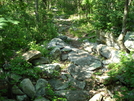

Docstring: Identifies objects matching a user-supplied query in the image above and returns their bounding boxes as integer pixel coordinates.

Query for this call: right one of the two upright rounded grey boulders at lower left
[35,79,48,96]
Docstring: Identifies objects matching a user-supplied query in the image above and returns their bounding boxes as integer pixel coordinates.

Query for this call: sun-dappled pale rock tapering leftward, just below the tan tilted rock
[36,63,61,76]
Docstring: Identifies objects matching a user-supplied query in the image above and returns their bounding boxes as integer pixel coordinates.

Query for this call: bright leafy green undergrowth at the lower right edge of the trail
[107,53,134,101]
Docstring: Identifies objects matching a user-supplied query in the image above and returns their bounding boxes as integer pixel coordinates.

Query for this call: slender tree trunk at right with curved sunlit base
[117,0,129,52]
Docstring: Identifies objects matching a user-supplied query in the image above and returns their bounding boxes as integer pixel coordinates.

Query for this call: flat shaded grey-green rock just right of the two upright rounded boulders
[49,79,69,90]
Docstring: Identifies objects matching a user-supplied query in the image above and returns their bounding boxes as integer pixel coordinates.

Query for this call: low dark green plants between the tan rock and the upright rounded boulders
[6,57,41,79]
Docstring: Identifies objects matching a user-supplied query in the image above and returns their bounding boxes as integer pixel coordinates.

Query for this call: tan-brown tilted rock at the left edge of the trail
[22,50,42,61]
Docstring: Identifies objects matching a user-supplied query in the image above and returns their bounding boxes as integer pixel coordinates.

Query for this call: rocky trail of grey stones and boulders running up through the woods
[2,13,133,101]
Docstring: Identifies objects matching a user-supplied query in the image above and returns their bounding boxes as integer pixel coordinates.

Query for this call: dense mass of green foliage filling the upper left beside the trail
[0,0,57,66]
